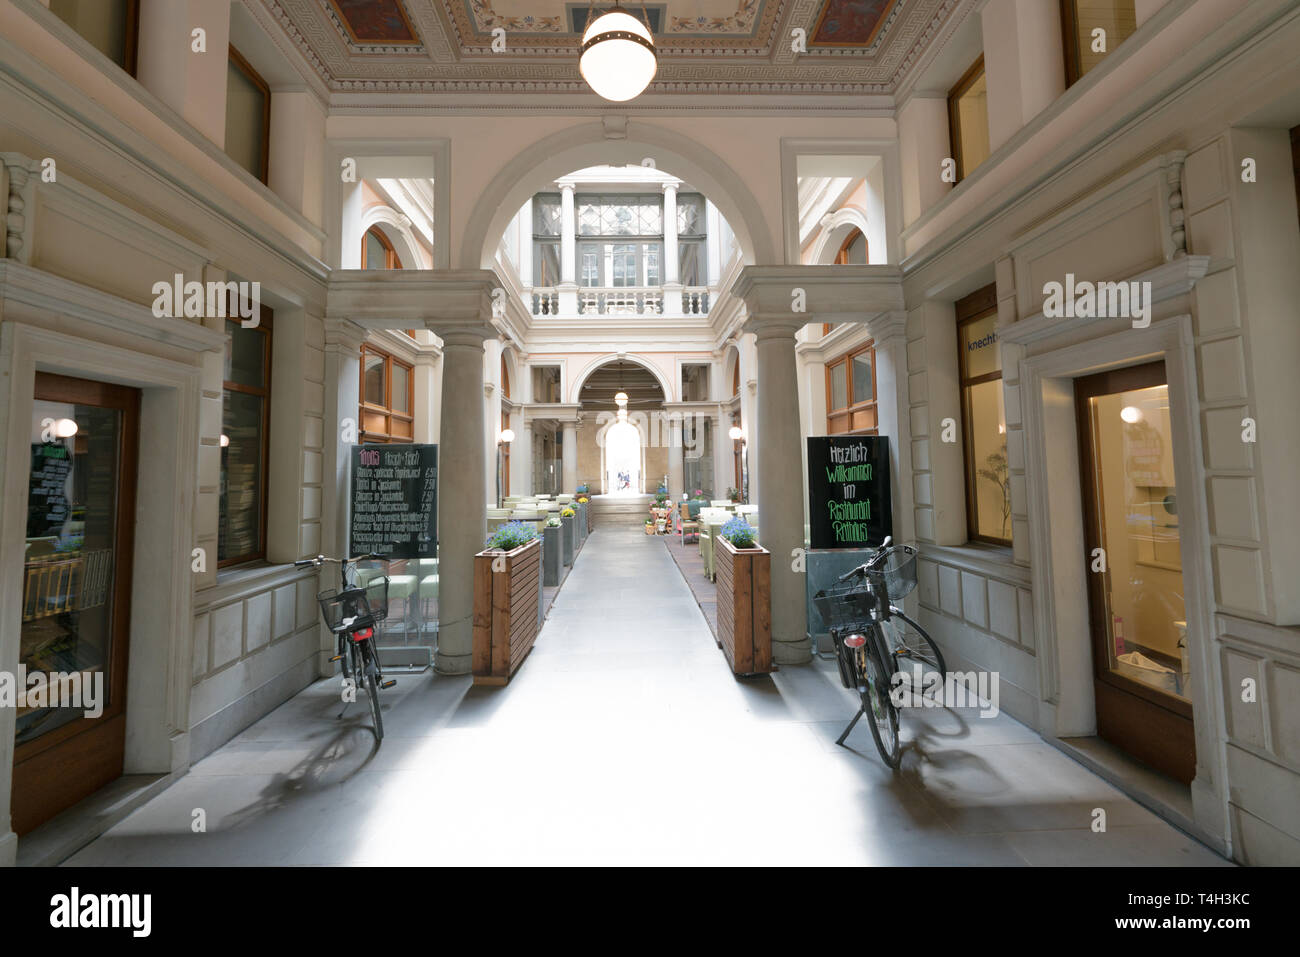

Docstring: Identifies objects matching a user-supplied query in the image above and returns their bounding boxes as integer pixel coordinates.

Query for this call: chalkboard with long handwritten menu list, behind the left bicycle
[348,445,438,562]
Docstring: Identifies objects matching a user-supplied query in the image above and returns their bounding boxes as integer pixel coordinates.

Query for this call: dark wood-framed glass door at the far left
[12,372,139,835]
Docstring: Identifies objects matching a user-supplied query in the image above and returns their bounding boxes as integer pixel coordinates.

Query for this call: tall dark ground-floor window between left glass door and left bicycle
[217,303,273,567]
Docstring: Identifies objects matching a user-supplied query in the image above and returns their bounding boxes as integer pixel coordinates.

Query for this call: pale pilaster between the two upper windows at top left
[135,0,230,148]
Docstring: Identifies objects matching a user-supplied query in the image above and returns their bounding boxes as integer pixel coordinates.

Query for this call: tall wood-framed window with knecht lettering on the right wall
[957,285,1011,545]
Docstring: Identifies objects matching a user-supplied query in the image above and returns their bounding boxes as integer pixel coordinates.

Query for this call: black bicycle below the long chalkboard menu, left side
[294,553,397,741]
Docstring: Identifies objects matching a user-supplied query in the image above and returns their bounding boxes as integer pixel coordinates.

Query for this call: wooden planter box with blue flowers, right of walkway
[714,536,772,675]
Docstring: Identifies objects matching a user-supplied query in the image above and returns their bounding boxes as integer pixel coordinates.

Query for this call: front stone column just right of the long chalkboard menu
[434,324,494,675]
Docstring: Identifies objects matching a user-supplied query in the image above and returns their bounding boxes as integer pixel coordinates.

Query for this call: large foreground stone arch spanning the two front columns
[458,122,777,269]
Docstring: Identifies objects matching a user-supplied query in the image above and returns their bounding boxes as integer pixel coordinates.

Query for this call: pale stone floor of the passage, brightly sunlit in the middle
[69,527,1226,865]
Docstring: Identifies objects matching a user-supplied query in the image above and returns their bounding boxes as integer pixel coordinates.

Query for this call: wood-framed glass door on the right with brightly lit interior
[1075,361,1196,783]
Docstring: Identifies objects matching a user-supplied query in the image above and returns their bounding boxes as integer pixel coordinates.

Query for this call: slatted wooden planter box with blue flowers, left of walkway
[471,538,542,685]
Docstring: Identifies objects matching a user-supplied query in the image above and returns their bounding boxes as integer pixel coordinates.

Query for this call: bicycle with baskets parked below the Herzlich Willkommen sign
[813,537,948,768]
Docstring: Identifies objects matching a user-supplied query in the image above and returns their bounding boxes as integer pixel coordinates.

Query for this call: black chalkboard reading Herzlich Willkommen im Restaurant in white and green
[809,436,893,549]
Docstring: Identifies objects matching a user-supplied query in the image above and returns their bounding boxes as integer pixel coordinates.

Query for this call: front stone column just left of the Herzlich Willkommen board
[745,313,811,664]
